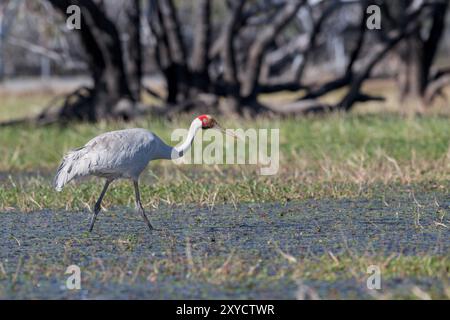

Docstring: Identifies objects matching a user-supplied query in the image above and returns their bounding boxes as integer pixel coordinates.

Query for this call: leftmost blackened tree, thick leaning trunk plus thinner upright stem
[40,0,142,122]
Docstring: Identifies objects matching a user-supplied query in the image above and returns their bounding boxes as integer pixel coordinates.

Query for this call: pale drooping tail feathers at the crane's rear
[53,147,87,191]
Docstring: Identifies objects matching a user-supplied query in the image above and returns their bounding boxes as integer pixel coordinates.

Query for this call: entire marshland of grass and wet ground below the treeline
[0,91,450,299]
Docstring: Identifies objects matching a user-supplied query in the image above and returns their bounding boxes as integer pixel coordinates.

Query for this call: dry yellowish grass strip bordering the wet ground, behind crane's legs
[0,162,450,212]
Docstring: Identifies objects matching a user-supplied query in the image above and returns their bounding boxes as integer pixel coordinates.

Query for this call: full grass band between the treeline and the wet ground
[0,114,450,211]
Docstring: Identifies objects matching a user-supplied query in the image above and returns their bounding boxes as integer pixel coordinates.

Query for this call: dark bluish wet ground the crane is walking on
[0,194,450,299]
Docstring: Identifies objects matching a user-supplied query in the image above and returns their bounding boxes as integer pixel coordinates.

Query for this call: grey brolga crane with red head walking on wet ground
[54,115,227,232]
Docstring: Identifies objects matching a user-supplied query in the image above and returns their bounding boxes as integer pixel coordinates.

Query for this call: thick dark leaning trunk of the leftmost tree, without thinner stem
[49,0,136,121]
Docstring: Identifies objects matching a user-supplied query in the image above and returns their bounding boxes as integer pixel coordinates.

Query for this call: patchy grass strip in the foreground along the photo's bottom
[0,251,450,299]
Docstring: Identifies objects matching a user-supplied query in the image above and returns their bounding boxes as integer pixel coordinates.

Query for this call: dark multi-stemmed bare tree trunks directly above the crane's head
[149,0,305,113]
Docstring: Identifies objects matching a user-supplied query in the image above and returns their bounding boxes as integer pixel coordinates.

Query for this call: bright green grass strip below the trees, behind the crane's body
[0,115,450,171]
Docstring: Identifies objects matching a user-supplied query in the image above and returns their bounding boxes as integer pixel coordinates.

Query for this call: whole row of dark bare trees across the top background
[0,0,450,122]
